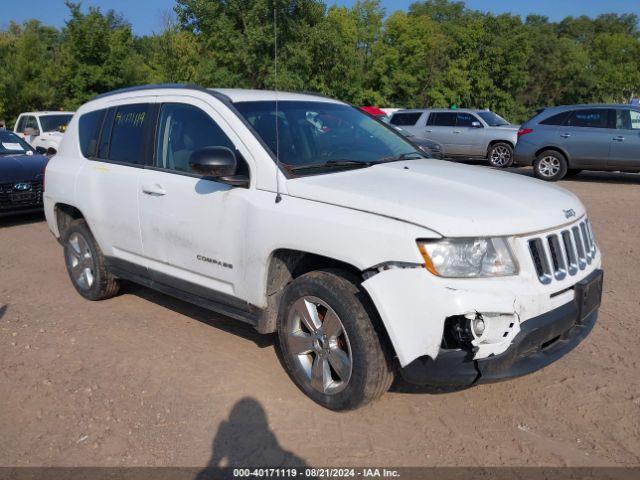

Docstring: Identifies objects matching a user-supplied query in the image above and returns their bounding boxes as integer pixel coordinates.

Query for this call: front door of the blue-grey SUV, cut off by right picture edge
[609,108,640,170]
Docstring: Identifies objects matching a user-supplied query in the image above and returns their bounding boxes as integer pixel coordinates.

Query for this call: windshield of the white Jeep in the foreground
[235,101,423,172]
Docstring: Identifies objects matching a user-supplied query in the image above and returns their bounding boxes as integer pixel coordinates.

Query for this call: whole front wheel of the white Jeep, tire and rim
[278,270,394,410]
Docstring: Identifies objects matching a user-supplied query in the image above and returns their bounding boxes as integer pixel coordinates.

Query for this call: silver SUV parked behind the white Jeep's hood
[390,109,518,168]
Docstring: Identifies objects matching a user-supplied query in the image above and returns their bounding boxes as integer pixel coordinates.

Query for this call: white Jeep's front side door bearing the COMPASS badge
[138,95,250,308]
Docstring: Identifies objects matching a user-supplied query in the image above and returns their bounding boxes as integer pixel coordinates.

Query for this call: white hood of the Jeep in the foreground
[287,160,584,237]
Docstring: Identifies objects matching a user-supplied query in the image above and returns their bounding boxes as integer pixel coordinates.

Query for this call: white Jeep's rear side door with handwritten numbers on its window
[76,98,153,276]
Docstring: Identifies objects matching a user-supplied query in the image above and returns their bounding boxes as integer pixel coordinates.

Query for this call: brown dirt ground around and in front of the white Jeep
[0,170,640,466]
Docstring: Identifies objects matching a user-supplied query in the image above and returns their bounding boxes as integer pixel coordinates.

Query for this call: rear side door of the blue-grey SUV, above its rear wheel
[557,108,615,167]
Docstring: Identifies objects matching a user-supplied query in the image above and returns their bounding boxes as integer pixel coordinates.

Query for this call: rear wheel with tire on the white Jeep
[62,220,120,300]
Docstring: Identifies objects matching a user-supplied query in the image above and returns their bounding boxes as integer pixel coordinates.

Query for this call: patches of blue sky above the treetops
[5,0,640,34]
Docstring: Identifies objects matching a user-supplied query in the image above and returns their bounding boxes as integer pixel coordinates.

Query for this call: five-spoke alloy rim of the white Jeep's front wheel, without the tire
[286,296,353,395]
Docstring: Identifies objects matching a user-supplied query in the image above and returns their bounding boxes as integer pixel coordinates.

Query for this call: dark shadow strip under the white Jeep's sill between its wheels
[121,282,276,348]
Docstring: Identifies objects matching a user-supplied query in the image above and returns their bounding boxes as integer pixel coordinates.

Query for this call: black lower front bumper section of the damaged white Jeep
[401,270,602,387]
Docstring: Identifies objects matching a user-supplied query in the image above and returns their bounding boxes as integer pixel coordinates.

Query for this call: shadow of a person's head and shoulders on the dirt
[196,397,307,480]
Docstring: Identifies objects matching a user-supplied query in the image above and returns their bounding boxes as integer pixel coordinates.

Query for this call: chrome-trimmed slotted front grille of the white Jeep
[528,219,596,284]
